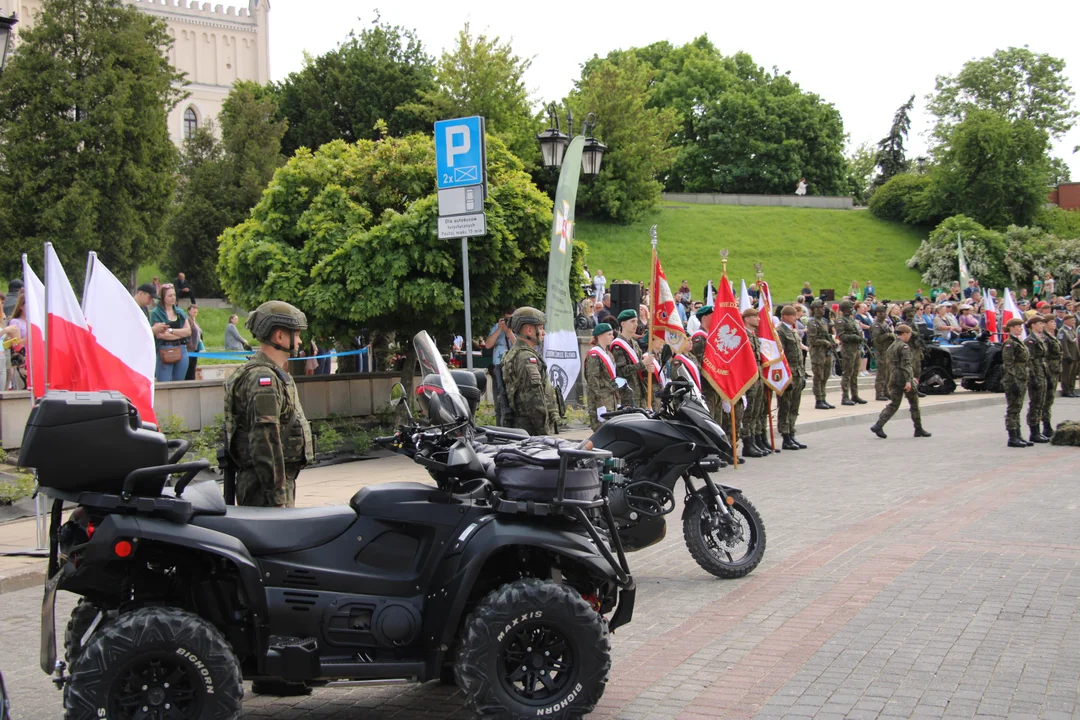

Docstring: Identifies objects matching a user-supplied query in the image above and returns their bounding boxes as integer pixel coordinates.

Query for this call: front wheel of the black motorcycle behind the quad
[683,492,765,580]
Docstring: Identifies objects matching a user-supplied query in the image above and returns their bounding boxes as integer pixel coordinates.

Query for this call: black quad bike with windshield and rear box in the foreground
[27,332,635,720]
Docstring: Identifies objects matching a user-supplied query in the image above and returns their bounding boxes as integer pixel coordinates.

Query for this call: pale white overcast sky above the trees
[263,0,1080,180]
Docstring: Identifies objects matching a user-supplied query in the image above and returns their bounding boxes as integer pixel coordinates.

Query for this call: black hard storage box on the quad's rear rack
[18,391,168,495]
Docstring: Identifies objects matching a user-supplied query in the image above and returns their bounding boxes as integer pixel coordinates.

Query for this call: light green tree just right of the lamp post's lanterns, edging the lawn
[570,55,678,223]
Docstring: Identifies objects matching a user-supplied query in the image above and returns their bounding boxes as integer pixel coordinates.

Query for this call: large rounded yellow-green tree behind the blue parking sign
[218,135,583,382]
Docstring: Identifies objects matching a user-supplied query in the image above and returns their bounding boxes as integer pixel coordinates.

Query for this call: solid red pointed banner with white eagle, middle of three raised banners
[702,275,758,405]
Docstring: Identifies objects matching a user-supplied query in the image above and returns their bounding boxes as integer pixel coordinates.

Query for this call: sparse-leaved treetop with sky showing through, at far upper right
[927,45,1078,138]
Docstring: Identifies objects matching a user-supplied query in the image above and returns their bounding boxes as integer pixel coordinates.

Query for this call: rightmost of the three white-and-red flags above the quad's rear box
[82,253,158,423]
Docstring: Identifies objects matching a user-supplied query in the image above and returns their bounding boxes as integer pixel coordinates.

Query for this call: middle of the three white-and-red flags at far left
[45,243,103,391]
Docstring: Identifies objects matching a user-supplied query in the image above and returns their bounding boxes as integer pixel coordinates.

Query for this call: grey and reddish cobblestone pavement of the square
[0,399,1080,720]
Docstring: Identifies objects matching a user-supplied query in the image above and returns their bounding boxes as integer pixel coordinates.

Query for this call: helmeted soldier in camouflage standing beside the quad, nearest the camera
[225,300,314,507]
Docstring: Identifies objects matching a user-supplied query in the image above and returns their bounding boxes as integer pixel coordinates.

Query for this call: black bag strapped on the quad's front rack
[495,437,600,502]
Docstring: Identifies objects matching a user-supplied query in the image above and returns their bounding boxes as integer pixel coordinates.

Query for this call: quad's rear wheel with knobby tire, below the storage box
[64,607,244,720]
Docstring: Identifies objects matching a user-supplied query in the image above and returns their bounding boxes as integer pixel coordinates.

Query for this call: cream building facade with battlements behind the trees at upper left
[15,0,270,145]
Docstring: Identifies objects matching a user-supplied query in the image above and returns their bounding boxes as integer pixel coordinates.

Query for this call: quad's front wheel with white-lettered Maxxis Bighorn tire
[454,580,611,720]
